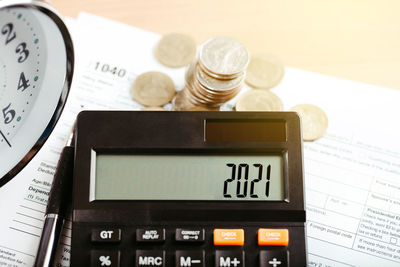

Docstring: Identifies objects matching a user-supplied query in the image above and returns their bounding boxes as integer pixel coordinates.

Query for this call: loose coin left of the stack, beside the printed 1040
[131,72,175,107]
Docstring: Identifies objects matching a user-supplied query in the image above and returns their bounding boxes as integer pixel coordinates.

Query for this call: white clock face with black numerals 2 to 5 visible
[0,6,69,182]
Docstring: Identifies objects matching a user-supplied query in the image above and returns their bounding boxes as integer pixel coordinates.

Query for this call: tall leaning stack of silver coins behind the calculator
[174,37,249,110]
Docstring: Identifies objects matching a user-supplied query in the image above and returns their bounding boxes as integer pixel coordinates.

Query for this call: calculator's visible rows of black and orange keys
[86,227,289,267]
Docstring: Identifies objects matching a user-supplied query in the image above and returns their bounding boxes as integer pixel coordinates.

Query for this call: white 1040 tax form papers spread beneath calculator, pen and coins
[0,13,400,267]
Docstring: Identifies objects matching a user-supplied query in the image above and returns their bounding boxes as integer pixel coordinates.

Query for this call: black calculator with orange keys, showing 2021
[71,111,306,267]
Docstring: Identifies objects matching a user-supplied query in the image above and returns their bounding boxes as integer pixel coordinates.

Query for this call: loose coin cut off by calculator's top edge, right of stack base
[235,90,283,111]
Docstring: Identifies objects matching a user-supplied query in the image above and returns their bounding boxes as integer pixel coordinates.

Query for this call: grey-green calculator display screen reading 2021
[90,154,285,201]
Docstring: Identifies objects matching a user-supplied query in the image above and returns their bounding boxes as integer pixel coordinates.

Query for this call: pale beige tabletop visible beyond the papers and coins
[52,0,400,89]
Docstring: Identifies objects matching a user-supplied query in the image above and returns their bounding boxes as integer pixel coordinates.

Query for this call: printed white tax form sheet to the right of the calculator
[268,69,400,267]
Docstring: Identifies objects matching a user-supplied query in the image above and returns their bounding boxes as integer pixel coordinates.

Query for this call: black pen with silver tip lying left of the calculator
[34,127,75,267]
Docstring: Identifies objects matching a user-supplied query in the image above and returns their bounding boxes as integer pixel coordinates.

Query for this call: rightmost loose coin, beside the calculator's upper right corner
[290,104,328,141]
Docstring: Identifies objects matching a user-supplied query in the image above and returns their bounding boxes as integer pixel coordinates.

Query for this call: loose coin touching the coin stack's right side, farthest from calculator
[246,55,284,88]
